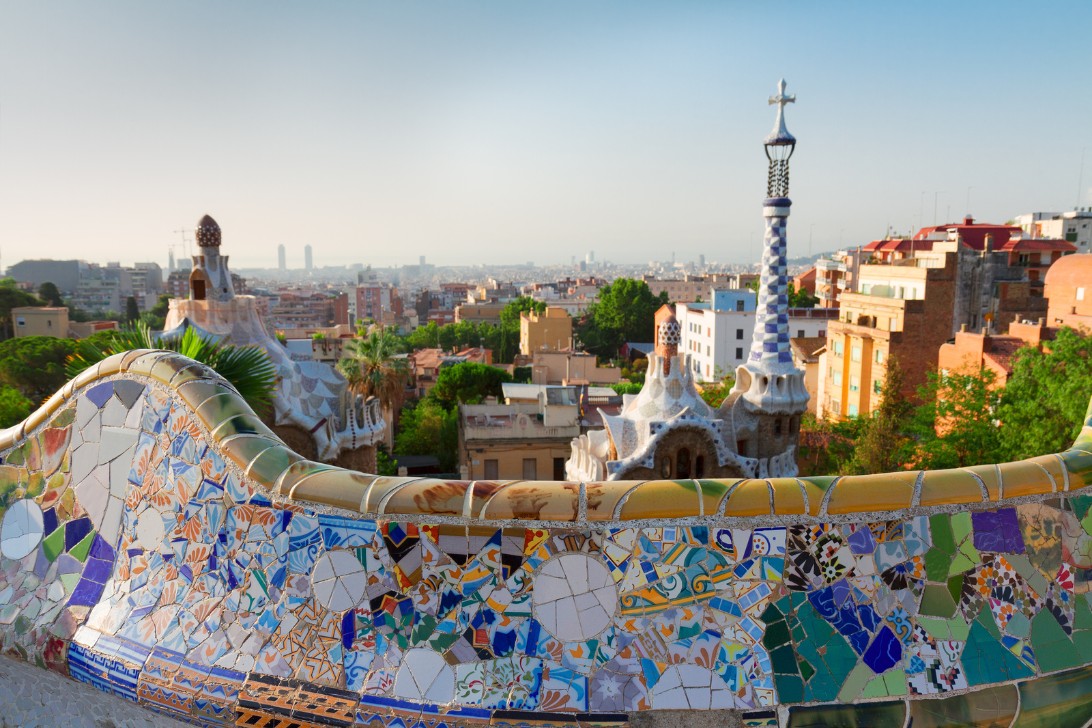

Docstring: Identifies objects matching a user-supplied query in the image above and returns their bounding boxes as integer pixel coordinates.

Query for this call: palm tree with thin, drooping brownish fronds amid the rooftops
[337,329,410,411]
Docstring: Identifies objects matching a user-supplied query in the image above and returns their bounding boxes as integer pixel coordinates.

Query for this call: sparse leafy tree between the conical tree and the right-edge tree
[909,369,1000,469]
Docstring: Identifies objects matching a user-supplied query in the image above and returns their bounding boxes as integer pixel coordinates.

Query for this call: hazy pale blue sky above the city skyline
[0,0,1092,266]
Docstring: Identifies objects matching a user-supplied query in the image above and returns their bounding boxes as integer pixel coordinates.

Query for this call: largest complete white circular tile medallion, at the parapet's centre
[532,553,618,642]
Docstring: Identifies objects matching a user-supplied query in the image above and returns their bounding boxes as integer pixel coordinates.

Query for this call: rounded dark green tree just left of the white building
[577,278,667,359]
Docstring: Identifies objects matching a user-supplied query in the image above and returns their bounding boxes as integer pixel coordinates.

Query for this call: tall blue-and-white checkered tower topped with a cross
[736,79,808,414]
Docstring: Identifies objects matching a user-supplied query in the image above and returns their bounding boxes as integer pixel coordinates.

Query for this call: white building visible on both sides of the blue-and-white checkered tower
[675,289,838,382]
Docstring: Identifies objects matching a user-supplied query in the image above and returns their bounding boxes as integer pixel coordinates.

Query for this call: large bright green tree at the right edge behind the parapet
[997,327,1092,460]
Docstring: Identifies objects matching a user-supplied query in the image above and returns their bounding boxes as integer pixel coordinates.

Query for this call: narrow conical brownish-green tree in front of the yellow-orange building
[841,357,913,475]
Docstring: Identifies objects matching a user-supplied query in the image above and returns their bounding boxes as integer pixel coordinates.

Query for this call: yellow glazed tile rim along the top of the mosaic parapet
[6,349,1092,522]
